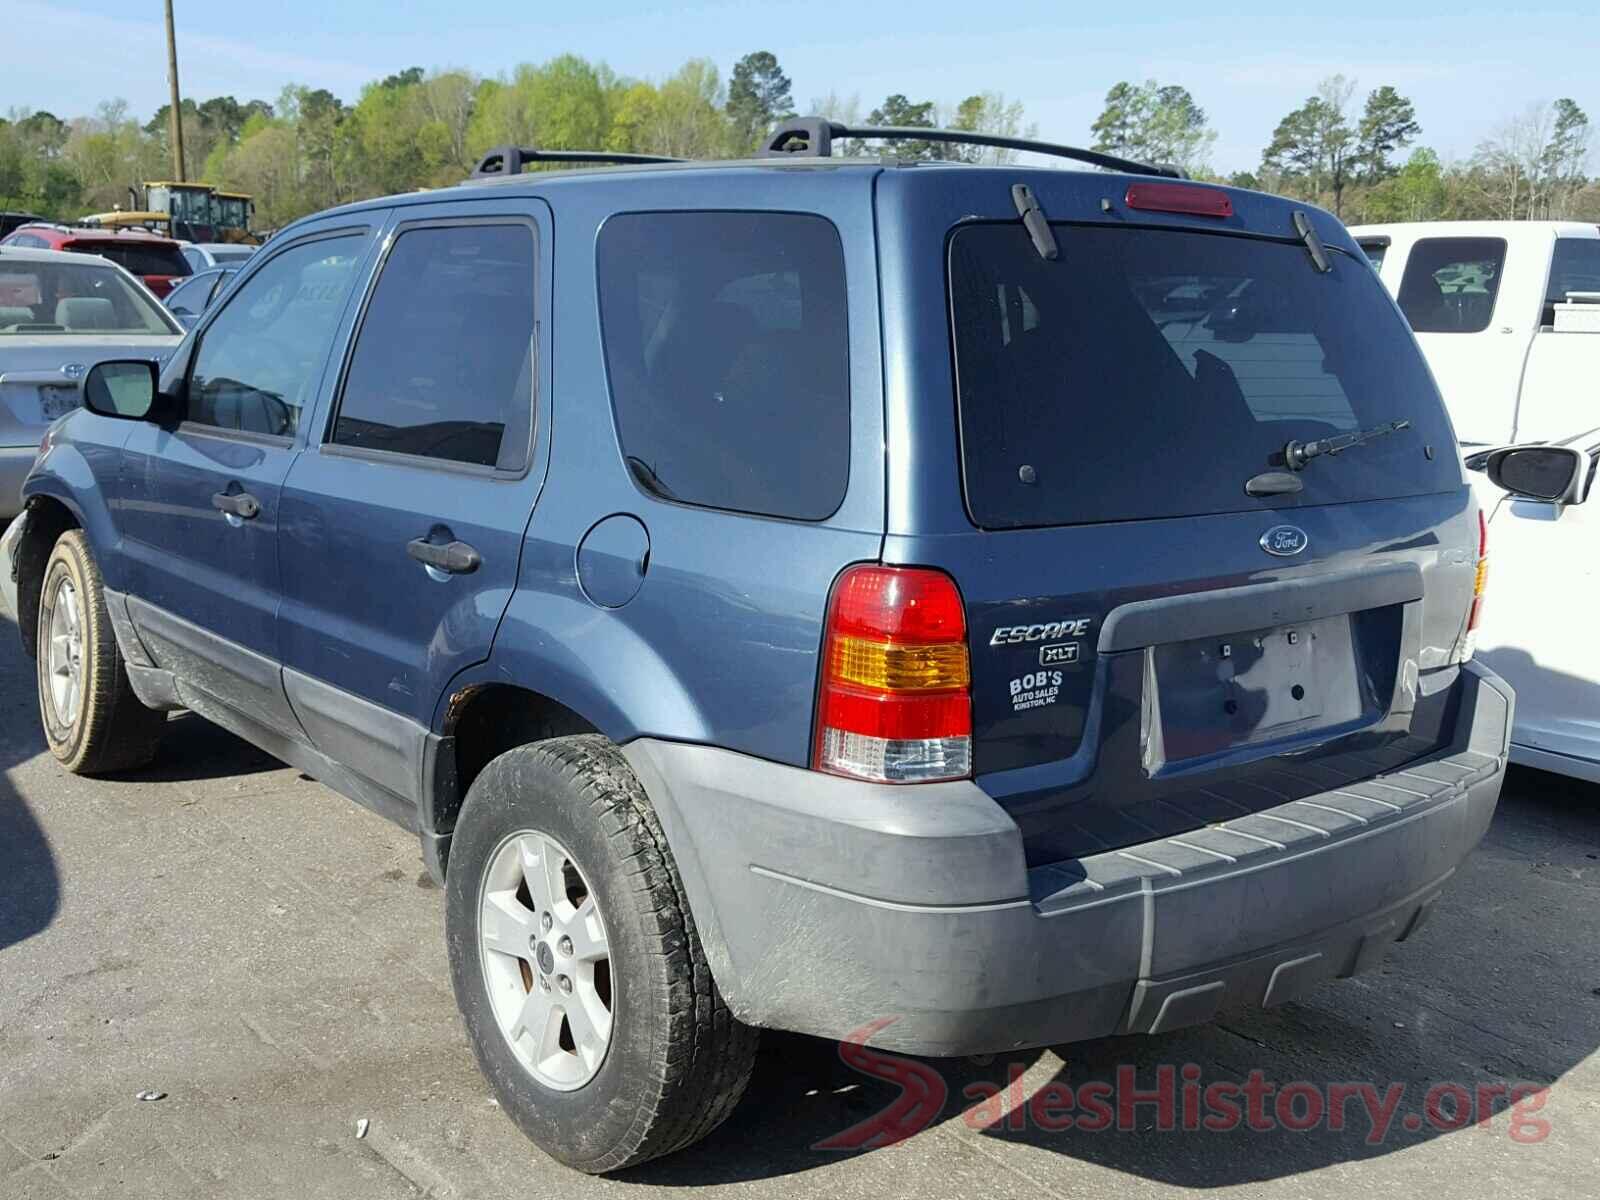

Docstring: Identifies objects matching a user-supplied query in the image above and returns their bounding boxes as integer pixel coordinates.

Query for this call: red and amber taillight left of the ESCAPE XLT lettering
[813,565,973,782]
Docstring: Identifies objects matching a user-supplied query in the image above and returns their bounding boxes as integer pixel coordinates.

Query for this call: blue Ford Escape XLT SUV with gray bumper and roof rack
[0,120,1512,1171]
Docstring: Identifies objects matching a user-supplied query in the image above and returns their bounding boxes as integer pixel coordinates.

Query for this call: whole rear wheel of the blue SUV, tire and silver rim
[445,734,757,1174]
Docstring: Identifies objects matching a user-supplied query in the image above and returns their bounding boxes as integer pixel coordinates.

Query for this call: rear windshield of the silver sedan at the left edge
[0,259,182,338]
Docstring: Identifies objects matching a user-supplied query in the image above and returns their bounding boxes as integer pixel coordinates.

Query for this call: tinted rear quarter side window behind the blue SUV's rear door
[598,213,850,520]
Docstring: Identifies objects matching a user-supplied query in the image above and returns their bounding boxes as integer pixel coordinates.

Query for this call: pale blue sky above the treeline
[0,0,1600,171]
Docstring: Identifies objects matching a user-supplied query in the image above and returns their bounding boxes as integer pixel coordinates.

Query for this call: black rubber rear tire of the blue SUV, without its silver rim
[445,734,757,1174]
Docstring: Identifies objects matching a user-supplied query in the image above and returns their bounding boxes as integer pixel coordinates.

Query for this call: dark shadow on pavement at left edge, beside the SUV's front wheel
[0,522,61,950]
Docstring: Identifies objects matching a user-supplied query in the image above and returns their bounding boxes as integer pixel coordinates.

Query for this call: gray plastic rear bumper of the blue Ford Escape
[626,664,1512,1054]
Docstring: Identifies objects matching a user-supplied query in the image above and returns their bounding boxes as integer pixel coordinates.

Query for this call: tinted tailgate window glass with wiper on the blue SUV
[949,224,1461,528]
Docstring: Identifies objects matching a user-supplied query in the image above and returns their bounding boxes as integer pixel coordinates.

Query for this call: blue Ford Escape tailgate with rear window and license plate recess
[880,171,1477,864]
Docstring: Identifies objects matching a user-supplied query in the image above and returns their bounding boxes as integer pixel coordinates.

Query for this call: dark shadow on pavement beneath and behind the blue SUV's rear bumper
[619,768,1600,1189]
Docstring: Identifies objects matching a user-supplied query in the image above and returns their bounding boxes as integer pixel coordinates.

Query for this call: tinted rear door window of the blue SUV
[333,224,538,472]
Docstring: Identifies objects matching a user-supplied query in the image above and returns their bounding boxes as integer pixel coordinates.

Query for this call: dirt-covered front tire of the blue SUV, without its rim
[34,530,166,774]
